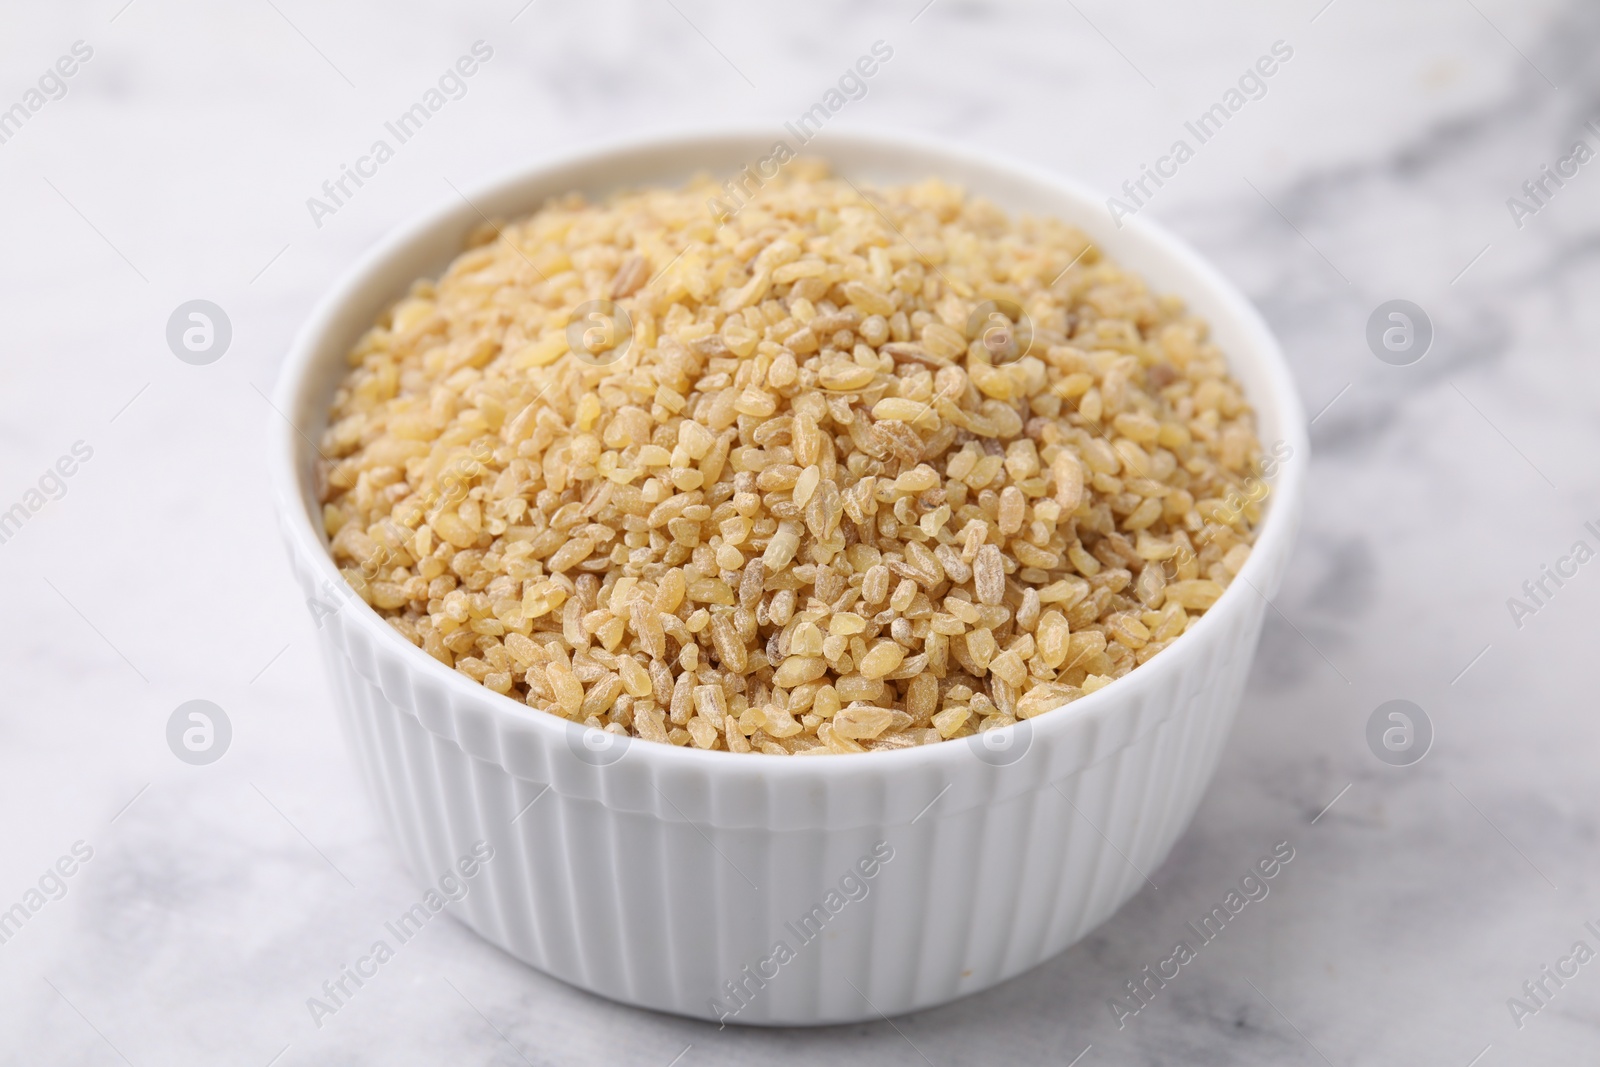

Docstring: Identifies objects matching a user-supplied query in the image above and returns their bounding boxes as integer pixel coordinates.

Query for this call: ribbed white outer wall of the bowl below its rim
[284,521,1286,1024]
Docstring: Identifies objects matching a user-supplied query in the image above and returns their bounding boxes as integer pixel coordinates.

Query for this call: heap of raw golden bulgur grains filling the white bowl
[323,160,1261,755]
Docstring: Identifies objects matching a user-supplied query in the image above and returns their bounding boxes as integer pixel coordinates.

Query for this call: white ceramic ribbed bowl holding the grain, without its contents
[272,130,1309,1024]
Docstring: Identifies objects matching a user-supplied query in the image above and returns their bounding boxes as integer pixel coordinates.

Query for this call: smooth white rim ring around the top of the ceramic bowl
[267,123,1310,779]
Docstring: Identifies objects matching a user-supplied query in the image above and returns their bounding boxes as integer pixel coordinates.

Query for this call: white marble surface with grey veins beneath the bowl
[0,0,1600,1067]
